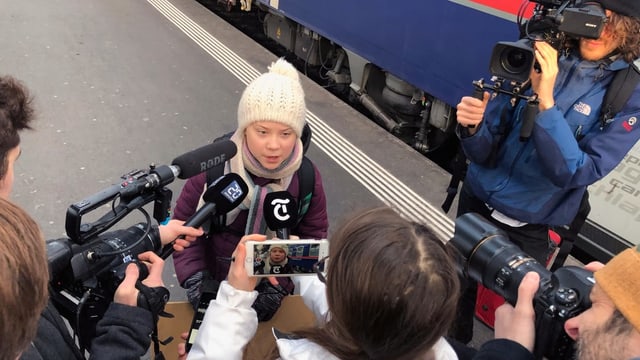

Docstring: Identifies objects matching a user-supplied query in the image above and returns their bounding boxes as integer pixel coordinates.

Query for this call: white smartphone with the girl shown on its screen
[245,239,329,277]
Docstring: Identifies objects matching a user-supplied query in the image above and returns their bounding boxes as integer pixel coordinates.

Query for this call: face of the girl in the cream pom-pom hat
[244,121,298,170]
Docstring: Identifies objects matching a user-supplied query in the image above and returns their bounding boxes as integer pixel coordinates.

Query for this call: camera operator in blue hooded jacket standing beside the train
[452,0,640,343]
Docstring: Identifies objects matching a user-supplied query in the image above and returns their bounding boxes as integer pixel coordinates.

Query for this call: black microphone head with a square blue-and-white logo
[202,173,249,214]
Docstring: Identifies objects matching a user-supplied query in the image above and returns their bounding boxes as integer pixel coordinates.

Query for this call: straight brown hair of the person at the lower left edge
[0,197,49,360]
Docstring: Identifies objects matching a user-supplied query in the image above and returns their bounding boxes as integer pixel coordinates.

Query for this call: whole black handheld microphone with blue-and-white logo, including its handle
[160,173,249,259]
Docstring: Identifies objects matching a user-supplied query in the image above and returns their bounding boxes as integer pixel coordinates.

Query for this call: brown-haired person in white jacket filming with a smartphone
[188,207,459,360]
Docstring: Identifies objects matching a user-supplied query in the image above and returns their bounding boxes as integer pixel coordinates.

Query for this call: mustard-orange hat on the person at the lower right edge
[595,246,640,331]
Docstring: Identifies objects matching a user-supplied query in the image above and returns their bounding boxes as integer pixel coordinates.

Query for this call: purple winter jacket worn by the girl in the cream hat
[173,165,329,285]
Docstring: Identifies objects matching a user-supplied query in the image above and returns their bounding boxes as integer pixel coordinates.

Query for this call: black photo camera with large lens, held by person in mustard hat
[448,213,594,360]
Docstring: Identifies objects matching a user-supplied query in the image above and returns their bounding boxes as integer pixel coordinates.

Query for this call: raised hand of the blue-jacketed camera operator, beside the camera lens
[531,41,558,111]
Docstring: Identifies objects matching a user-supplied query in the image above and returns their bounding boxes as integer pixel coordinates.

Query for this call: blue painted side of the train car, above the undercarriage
[259,0,520,105]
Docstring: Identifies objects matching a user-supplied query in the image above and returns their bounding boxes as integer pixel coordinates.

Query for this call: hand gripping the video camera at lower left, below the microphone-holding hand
[113,251,164,306]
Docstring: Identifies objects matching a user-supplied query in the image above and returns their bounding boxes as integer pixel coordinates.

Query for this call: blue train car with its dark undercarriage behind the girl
[248,0,519,153]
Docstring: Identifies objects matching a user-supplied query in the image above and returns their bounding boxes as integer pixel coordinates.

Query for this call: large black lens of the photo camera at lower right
[450,213,552,304]
